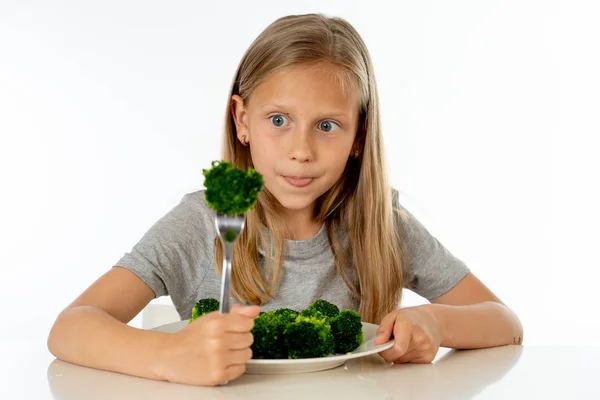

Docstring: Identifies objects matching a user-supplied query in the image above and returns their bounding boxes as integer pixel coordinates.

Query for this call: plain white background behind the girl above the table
[0,0,600,354]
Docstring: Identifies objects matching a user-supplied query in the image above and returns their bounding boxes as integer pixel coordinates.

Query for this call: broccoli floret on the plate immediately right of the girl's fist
[251,308,298,359]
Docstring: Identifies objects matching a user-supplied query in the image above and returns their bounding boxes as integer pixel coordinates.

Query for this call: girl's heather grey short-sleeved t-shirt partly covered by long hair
[115,190,469,319]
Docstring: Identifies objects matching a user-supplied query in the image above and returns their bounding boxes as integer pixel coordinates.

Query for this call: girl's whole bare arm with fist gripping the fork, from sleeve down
[48,268,260,386]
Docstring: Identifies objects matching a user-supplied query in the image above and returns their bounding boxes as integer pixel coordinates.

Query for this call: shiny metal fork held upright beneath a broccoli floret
[215,214,246,314]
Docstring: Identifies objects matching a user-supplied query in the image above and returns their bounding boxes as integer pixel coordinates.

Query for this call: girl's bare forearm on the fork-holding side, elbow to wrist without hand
[48,306,165,379]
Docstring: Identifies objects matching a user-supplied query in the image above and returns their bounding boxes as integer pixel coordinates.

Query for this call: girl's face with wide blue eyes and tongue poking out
[232,64,359,211]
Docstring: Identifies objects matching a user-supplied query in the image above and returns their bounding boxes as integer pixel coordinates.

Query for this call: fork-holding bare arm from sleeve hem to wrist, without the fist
[48,268,165,379]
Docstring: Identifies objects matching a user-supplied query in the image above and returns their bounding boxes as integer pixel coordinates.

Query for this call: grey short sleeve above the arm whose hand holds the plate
[392,190,469,300]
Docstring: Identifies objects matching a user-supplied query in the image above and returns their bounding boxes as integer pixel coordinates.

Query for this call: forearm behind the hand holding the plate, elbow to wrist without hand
[422,301,523,349]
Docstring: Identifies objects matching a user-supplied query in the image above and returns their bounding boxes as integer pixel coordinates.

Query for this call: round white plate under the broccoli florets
[152,320,394,374]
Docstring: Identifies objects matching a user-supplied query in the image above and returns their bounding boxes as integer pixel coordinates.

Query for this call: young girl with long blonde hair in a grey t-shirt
[48,15,523,385]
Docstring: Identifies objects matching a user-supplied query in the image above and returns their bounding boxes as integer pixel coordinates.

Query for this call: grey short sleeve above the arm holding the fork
[114,193,214,304]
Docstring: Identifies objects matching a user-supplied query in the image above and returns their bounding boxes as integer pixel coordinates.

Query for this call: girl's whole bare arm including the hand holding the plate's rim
[375,273,523,363]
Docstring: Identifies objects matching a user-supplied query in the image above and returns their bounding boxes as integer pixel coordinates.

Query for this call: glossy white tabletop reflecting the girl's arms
[0,335,600,400]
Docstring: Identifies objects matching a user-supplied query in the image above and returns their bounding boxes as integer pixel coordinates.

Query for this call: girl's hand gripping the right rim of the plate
[375,306,441,364]
